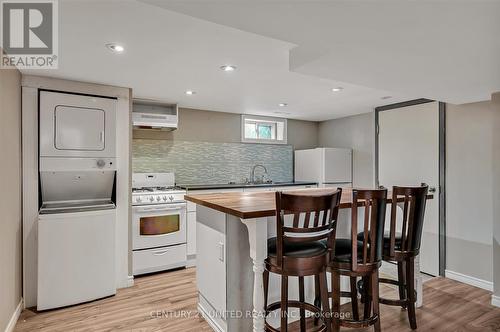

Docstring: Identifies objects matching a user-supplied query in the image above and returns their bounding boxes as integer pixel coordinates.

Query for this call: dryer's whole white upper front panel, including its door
[40,91,116,158]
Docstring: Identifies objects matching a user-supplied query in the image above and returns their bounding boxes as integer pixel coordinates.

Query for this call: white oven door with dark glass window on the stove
[132,203,186,250]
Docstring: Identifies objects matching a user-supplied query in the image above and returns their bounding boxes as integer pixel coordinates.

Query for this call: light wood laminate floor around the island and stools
[15,268,500,332]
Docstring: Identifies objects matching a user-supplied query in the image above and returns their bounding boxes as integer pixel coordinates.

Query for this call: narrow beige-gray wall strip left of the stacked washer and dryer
[0,66,22,331]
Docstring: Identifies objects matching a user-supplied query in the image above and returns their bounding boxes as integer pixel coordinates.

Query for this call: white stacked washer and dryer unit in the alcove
[37,91,116,310]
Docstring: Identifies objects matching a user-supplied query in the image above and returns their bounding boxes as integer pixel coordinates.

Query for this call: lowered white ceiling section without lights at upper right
[143,0,500,104]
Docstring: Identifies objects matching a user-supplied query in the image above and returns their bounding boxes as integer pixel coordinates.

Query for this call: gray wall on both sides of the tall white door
[318,102,500,286]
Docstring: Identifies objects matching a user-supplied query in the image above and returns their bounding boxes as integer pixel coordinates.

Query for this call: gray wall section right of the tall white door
[446,101,495,282]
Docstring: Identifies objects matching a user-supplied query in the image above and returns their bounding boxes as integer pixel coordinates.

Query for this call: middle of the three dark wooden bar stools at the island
[327,189,387,331]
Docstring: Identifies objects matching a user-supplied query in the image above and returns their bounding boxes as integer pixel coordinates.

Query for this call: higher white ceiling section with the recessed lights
[24,0,419,120]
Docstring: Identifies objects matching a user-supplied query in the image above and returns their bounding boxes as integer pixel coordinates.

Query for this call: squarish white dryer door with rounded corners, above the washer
[54,105,105,151]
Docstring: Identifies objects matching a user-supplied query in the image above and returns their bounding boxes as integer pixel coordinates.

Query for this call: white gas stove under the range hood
[132,173,187,275]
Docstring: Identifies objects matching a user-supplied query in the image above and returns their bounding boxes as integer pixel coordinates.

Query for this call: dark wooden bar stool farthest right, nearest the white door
[379,184,429,329]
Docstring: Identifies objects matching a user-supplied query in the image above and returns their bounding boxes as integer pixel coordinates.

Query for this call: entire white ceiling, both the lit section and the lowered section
[24,0,500,121]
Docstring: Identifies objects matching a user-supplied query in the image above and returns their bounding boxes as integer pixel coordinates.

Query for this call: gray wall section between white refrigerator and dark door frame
[318,112,375,187]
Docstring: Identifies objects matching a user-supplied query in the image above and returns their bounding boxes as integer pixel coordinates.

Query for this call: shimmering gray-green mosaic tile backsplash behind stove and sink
[132,139,293,184]
